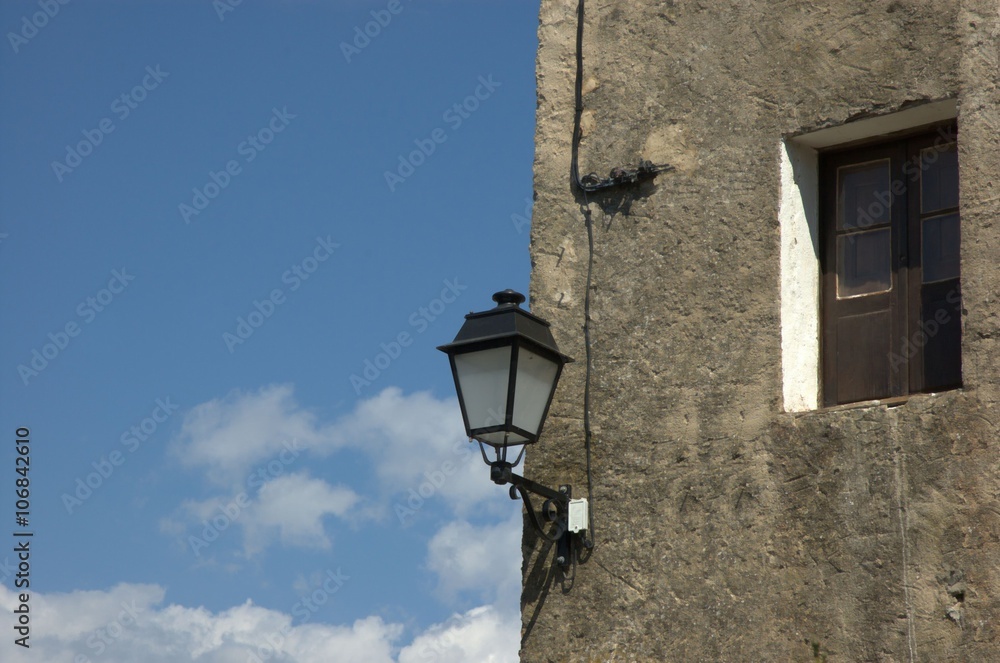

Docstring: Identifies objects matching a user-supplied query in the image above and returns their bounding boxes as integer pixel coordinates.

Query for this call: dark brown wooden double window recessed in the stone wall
[819,123,962,405]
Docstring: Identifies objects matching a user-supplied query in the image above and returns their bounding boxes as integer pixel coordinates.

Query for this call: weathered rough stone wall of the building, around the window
[521,0,1000,663]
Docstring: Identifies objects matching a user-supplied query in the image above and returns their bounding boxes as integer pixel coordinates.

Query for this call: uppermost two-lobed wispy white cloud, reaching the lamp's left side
[171,385,503,516]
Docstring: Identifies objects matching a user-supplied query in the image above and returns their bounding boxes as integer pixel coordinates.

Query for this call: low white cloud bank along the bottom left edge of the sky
[0,584,402,663]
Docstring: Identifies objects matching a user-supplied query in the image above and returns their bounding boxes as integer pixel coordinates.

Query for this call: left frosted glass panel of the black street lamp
[455,346,510,430]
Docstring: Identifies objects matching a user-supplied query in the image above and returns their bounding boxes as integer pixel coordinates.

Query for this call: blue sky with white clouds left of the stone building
[0,0,538,663]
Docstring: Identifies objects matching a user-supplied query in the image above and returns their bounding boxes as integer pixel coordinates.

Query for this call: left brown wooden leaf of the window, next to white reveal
[820,145,909,405]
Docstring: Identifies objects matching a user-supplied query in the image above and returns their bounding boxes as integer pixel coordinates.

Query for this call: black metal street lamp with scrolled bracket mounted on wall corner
[438,290,588,565]
